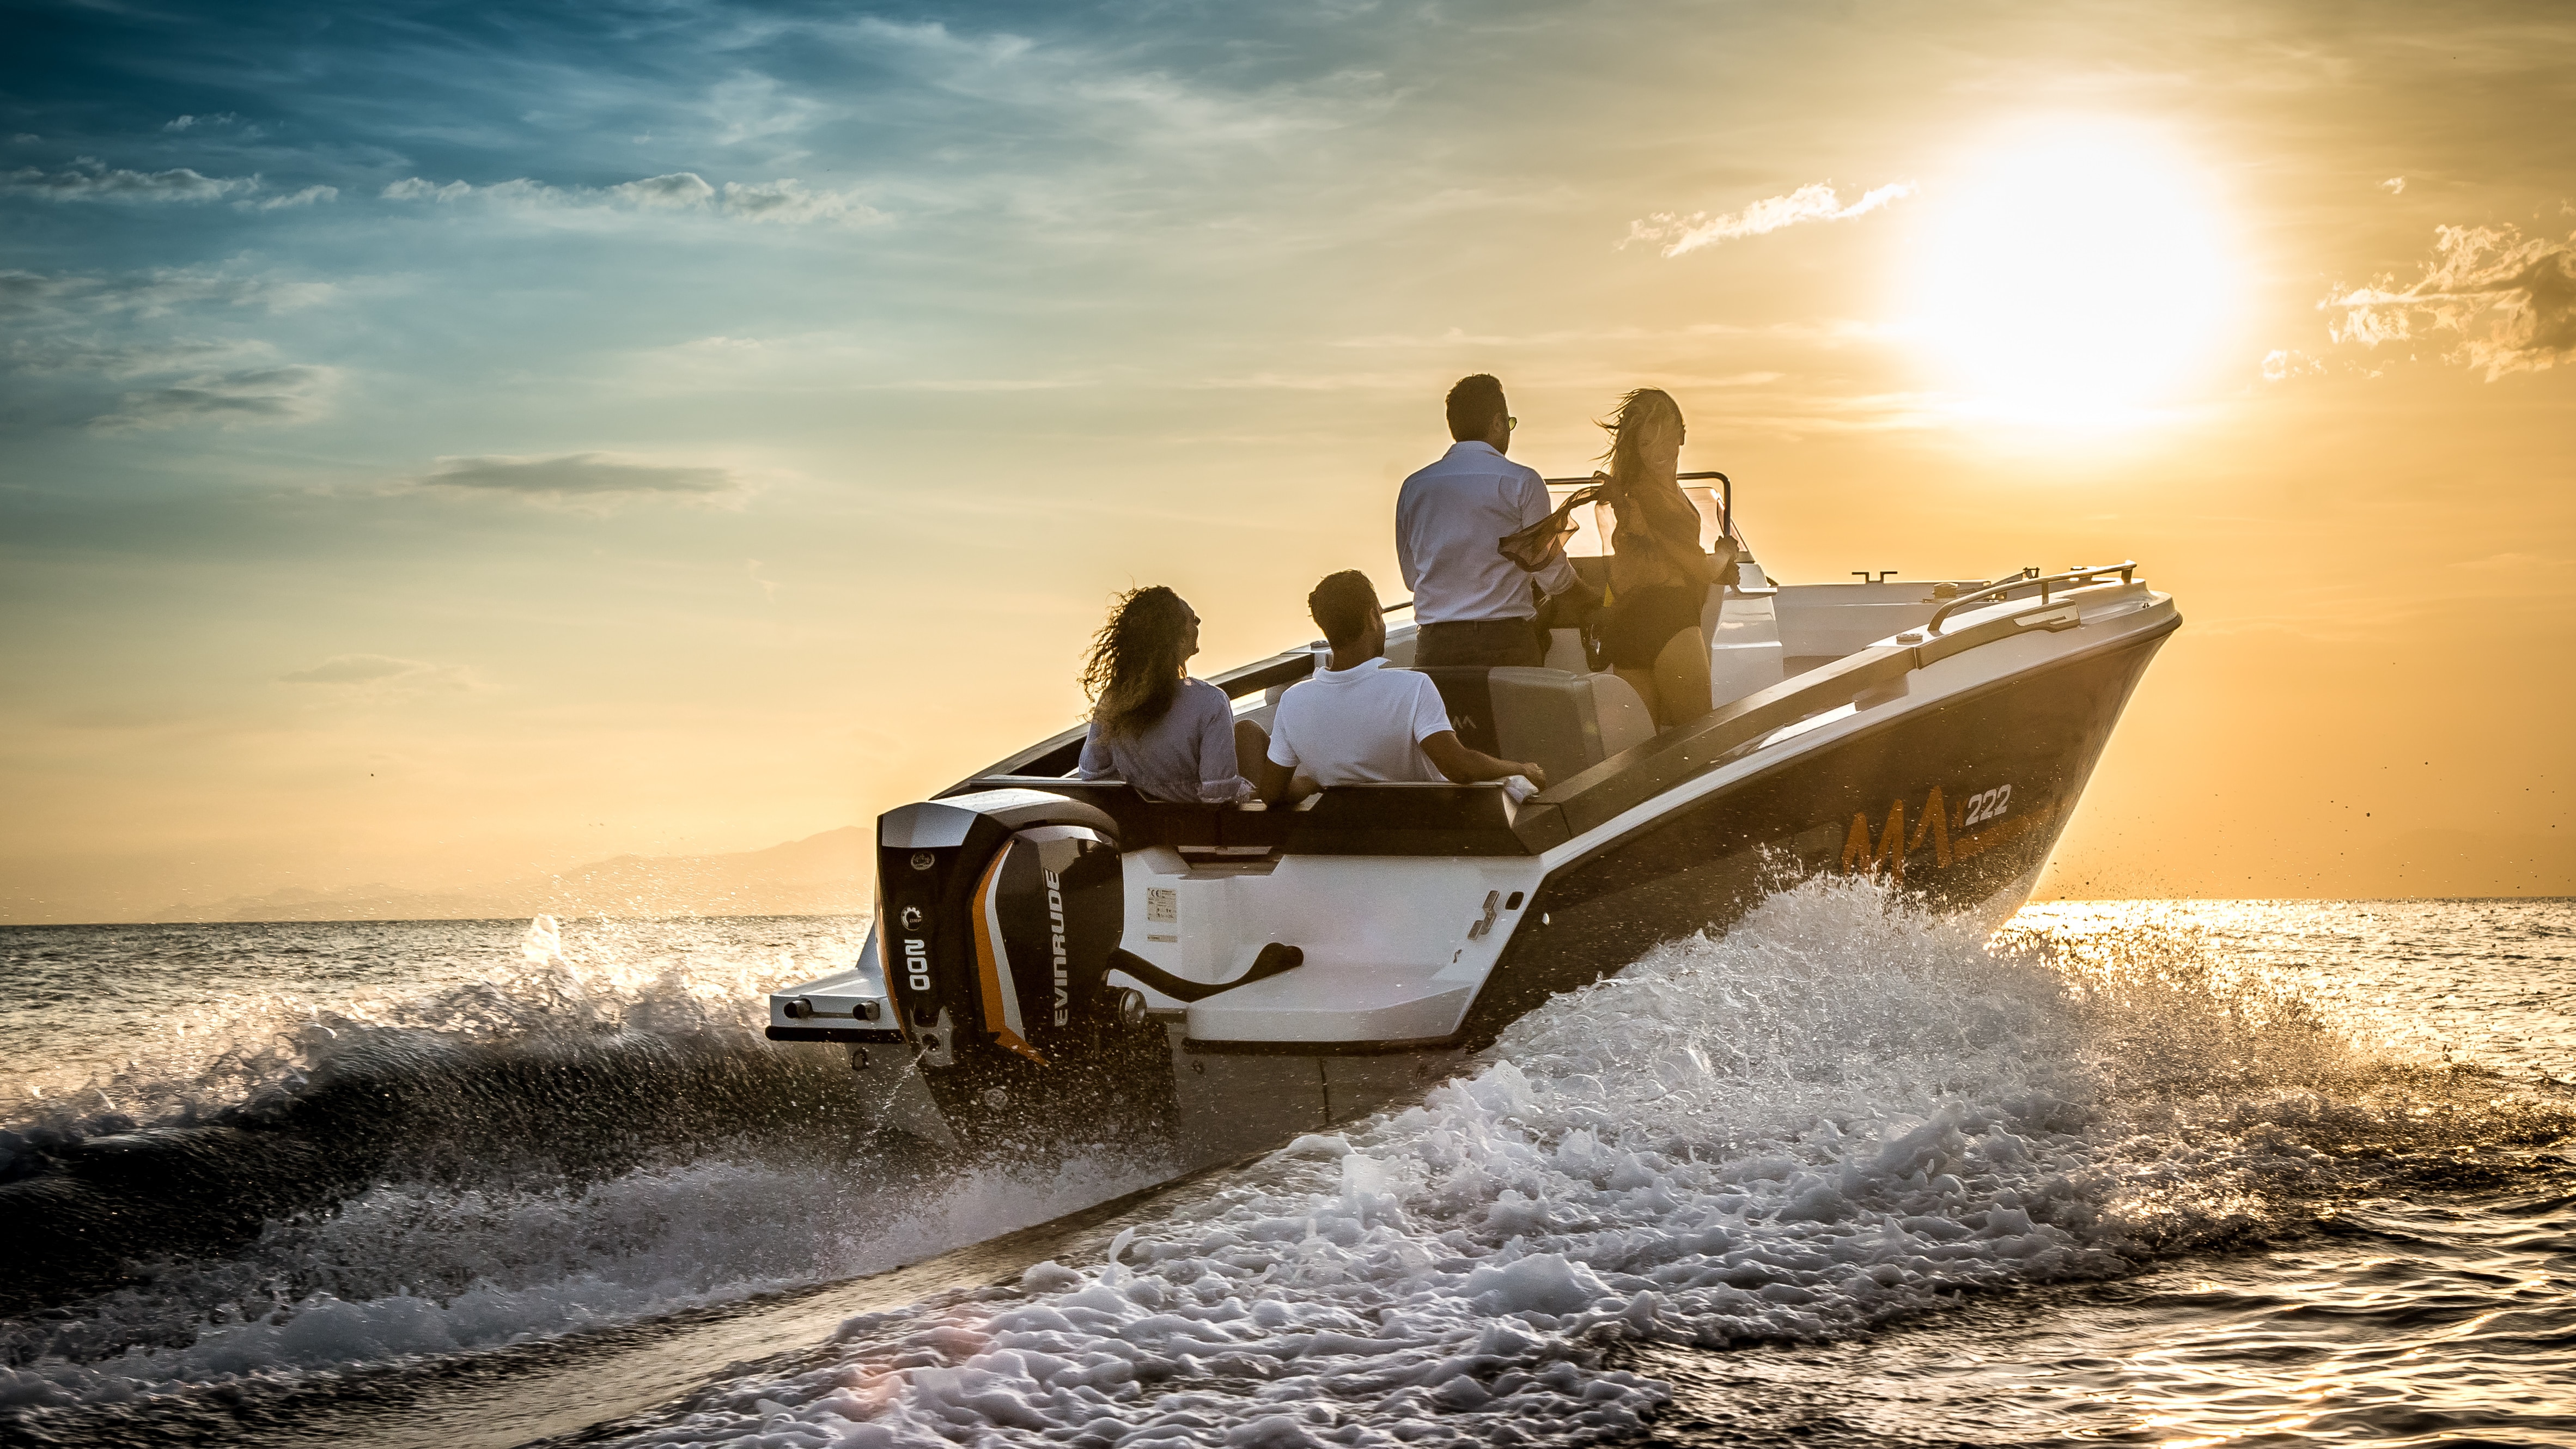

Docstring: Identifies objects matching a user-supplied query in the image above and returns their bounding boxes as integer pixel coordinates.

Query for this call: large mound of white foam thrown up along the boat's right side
[613,882,2442,1446]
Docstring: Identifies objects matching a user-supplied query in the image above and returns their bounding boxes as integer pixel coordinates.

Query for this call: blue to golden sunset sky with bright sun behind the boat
[0,0,2576,921]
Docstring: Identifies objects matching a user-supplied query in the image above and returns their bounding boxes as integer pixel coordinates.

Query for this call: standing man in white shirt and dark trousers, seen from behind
[1396,372,1579,668]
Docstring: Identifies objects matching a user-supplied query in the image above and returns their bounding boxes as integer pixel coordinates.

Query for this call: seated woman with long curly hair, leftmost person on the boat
[1079,583,1270,805]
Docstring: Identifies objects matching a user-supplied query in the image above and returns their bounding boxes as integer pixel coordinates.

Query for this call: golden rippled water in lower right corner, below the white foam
[1639,1168,2576,1446]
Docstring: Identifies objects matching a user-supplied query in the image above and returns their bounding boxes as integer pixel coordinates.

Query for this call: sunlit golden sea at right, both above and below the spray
[1633,900,2576,1449]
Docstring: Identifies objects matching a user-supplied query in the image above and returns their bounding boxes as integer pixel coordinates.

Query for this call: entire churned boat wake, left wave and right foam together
[0,879,2576,1446]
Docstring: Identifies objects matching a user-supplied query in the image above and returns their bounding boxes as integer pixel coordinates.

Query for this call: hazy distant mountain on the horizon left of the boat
[149,825,873,921]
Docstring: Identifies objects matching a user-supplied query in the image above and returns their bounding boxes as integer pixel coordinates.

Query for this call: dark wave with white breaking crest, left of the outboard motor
[0,921,906,1312]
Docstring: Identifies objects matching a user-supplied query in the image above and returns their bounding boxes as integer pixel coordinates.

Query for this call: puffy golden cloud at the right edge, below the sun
[2318,224,2576,381]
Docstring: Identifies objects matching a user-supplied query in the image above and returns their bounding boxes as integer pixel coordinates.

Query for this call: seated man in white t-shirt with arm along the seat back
[1259,570,1548,799]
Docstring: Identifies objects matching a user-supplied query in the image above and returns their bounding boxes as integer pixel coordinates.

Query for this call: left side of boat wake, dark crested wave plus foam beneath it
[0,921,1167,1423]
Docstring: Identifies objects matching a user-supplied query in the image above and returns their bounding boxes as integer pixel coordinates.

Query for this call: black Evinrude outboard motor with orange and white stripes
[876,789,1172,1144]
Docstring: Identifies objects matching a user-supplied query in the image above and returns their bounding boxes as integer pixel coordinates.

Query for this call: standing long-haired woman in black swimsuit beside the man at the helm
[1592,387,1734,729]
